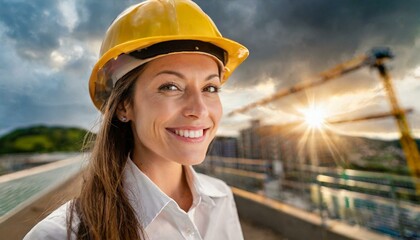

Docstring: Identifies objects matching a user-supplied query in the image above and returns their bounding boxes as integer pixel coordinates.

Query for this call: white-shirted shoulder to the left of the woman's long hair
[24,202,78,240]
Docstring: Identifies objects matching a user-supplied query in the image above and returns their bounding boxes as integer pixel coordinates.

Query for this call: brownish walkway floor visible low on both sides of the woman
[0,172,286,240]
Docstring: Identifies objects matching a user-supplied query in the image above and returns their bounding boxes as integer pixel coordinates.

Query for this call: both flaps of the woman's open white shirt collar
[123,158,227,228]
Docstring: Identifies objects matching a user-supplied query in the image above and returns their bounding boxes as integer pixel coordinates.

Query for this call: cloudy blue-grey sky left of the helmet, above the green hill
[0,1,133,132]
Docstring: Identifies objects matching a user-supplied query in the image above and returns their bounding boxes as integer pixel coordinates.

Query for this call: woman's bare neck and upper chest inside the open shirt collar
[132,148,192,212]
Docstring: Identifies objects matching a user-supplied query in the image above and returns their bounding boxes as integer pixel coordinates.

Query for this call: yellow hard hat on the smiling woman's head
[89,0,249,109]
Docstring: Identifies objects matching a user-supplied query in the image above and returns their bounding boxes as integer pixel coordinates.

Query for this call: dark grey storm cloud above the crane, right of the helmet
[197,0,420,90]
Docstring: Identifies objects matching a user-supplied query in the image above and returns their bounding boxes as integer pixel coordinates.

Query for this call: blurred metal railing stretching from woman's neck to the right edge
[196,156,420,239]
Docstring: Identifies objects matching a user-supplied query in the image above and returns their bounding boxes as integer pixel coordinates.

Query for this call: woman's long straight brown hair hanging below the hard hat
[67,65,145,239]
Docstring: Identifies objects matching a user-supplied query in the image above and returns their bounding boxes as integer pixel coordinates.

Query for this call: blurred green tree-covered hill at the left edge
[0,125,92,154]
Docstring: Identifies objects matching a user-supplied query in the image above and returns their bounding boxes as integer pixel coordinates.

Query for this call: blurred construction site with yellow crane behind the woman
[0,48,420,240]
